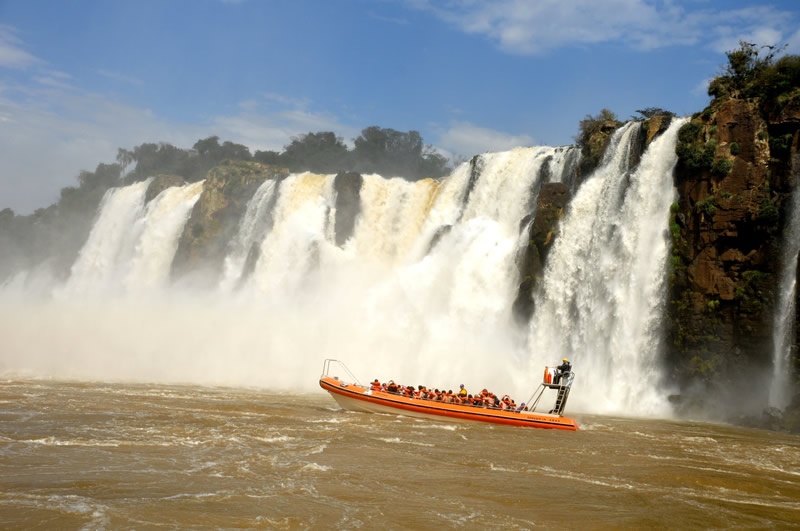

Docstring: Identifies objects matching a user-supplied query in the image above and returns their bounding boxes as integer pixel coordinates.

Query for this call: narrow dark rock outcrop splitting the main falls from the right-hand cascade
[512,183,571,323]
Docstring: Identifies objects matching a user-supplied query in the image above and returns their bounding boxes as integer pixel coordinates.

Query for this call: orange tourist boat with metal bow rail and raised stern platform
[319,359,578,431]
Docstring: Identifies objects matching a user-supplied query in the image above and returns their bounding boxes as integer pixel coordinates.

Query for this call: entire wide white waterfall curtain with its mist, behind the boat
[0,127,683,414]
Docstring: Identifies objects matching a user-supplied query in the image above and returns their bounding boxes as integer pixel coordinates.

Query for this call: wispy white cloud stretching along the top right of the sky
[408,0,797,54]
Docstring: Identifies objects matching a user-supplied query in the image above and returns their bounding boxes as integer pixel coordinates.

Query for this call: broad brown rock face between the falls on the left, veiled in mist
[170,161,289,282]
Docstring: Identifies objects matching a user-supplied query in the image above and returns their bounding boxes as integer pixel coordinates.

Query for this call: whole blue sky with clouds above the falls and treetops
[0,0,800,214]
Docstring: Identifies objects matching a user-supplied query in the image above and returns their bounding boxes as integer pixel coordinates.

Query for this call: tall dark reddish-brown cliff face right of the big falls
[667,95,800,420]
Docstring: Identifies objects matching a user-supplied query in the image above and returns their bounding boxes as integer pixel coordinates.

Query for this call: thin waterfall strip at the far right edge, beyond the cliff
[769,181,800,409]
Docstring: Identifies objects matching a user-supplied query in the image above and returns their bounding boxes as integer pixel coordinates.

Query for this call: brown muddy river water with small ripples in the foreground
[0,381,800,529]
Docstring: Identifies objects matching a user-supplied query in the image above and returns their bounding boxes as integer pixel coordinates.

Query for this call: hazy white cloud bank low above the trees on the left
[0,80,357,214]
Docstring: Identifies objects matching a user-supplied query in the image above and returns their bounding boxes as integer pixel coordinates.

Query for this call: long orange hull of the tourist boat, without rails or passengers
[319,376,578,431]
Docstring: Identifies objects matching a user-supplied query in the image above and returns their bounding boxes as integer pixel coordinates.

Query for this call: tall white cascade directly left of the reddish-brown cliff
[530,120,684,414]
